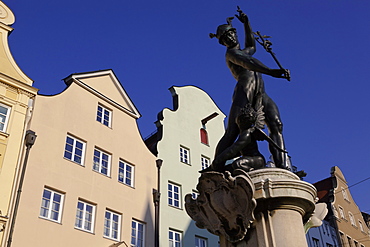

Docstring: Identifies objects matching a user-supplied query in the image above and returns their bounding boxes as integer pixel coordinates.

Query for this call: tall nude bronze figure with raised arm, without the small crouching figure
[210,7,291,170]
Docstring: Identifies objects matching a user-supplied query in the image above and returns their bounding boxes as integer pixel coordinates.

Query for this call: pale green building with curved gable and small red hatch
[146,86,225,247]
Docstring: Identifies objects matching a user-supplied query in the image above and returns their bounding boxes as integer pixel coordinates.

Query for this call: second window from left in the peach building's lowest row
[75,201,95,232]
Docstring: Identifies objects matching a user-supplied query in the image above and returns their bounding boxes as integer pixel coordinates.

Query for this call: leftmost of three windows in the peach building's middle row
[64,135,86,165]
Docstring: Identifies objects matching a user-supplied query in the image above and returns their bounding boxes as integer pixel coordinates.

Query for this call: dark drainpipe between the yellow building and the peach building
[7,130,36,247]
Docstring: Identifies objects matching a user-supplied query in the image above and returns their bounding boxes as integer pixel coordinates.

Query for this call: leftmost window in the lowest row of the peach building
[40,188,64,222]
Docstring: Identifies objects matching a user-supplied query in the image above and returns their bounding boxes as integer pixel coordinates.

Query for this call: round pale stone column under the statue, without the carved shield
[244,168,316,247]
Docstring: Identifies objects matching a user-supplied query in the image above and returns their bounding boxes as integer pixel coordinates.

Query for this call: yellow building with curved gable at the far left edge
[0,1,37,246]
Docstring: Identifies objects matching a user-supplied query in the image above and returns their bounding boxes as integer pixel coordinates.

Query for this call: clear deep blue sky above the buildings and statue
[4,0,370,212]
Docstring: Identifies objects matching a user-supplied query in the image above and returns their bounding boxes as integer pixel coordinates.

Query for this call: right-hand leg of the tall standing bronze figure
[262,94,292,170]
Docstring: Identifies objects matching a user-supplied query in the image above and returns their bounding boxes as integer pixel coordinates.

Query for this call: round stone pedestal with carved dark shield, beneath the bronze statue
[185,168,316,247]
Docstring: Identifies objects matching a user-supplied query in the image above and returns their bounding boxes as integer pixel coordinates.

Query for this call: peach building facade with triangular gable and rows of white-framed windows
[7,70,157,247]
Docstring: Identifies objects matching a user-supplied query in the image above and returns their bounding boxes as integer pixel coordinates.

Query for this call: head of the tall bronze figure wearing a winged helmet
[209,17,239,47]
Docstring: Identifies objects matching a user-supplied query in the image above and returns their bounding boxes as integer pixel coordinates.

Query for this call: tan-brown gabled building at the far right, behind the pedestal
[310,166,370,247]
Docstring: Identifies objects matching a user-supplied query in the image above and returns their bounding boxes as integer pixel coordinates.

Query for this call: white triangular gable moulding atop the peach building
[63,69,141,119]
